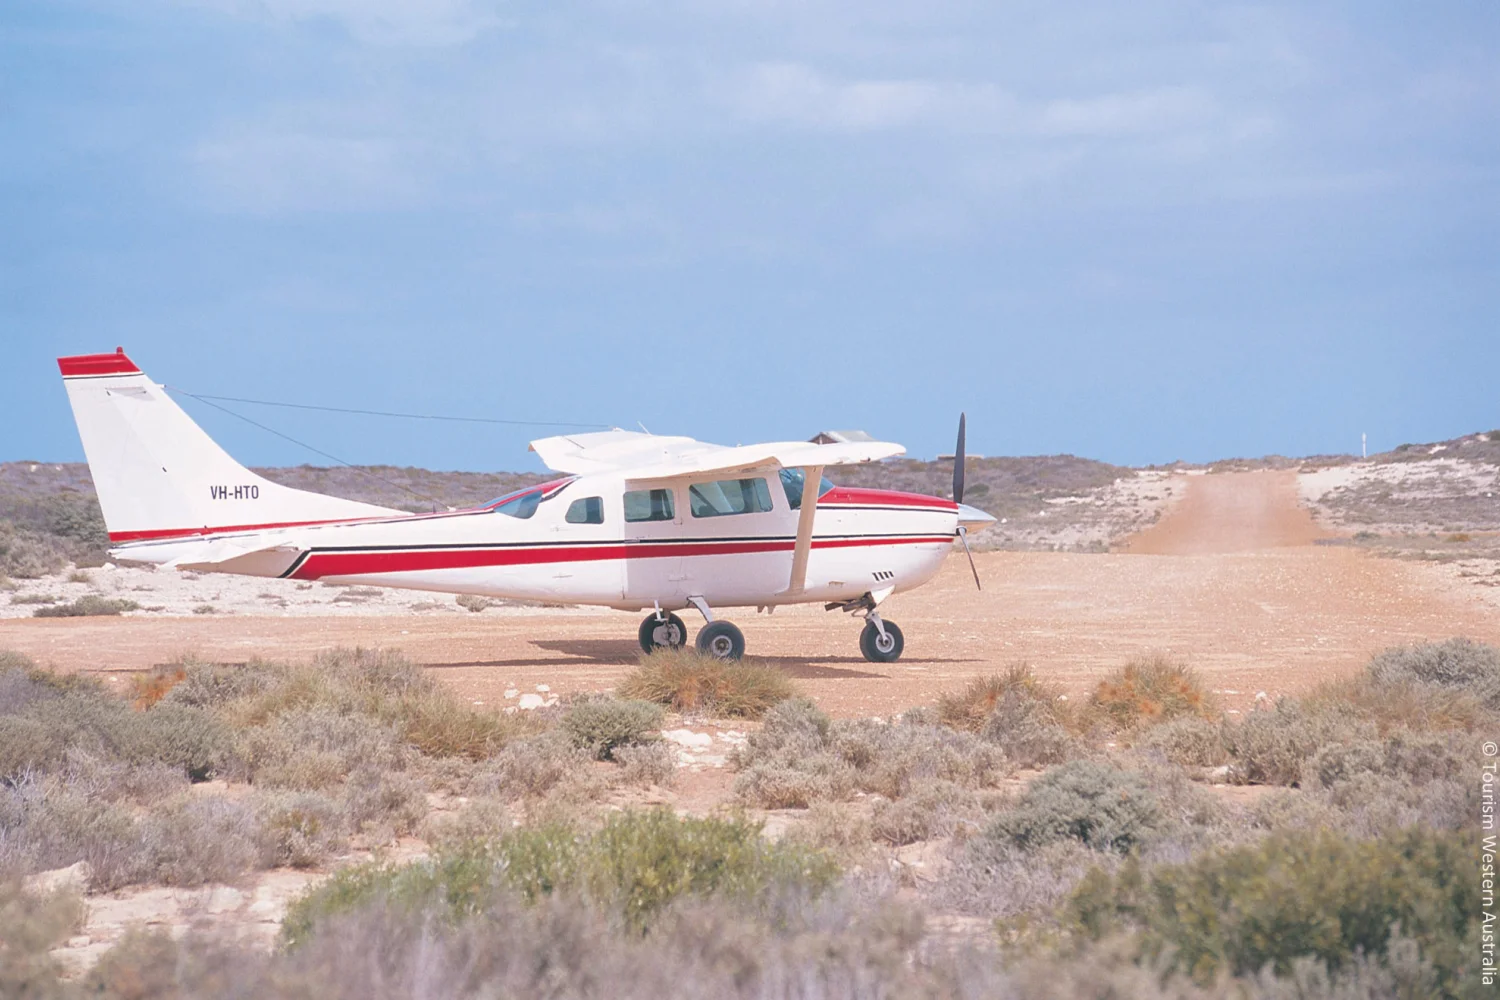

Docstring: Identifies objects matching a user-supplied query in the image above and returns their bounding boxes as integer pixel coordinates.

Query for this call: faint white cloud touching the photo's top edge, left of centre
[183,0,506,46]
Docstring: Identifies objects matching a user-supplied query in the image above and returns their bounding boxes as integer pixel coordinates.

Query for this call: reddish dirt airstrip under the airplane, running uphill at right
[0,472,1500,715]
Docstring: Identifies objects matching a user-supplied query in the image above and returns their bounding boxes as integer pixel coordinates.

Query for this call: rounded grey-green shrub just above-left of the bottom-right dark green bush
[984,760,1166,852]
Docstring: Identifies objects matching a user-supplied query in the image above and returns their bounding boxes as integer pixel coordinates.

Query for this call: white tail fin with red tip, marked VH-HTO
[57,348,402,544]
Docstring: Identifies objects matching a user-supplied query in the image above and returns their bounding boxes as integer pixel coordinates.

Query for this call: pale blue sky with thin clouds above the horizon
[0,0,1500,469]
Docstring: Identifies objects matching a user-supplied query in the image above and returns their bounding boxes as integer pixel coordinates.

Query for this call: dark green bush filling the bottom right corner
[1070,828,1481,993]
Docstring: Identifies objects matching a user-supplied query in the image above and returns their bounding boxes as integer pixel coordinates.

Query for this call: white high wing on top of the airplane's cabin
[531,430,906,480]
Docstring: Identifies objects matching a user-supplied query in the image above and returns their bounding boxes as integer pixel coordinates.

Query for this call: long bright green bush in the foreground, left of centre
[282,810,839,946]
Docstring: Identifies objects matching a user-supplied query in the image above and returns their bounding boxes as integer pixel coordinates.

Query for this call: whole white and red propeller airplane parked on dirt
[57,349,995,663]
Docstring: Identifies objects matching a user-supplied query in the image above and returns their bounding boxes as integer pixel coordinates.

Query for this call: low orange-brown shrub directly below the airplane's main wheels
[618,649,797,718]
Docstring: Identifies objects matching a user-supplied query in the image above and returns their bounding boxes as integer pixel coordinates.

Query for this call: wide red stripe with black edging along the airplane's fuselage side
[291,535,948,580]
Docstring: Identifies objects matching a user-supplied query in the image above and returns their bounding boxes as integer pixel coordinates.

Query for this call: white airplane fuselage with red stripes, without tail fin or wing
[113,469,960,610]
